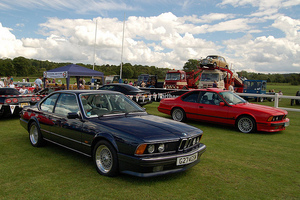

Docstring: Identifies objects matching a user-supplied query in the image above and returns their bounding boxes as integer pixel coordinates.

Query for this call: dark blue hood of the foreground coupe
[91,114,202,142]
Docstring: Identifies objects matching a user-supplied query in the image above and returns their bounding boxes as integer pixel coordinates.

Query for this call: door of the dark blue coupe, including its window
[50,93,83,150]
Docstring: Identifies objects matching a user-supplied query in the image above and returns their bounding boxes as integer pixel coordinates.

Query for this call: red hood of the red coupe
[234,103,287,115]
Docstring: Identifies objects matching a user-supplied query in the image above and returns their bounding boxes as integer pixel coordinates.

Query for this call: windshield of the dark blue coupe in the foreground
[80,94,145,117]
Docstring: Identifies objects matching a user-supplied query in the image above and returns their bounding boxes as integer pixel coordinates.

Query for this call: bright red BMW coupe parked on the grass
[158,88,289,133]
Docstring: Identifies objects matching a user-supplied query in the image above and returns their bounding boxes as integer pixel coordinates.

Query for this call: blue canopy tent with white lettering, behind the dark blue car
[44,64,104,89]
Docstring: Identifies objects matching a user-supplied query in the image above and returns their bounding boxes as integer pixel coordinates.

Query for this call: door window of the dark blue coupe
[54,94,79,116]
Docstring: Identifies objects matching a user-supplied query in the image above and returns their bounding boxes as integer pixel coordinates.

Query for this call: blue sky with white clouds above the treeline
[0,0,300,73]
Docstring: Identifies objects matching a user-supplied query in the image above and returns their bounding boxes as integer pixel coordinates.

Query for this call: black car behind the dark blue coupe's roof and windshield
[99,83,152,106]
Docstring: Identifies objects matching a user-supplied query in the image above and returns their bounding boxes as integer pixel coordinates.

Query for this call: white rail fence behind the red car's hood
[236,93,300,112]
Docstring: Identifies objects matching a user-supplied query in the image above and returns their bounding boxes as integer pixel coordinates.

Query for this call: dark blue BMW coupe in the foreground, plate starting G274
[20,90,206,177]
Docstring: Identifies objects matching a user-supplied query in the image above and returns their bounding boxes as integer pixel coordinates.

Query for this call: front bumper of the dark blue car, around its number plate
[118,143,206,177]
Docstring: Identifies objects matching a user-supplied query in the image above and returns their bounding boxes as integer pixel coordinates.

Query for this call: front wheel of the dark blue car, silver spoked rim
[93,140,118,176]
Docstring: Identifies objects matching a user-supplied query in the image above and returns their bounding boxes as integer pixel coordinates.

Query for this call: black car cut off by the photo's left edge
[0,87,44,116]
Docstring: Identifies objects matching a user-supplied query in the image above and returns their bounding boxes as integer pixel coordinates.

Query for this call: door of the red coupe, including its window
[195,91,229,123]
